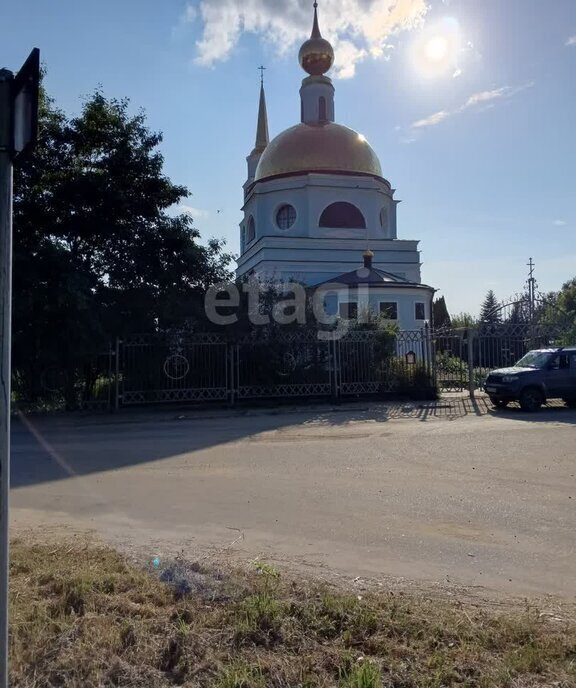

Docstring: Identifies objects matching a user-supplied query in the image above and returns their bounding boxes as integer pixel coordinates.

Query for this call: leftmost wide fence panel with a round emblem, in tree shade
[117,334,230,405]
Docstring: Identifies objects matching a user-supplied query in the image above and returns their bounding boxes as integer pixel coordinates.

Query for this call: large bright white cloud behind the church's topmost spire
[183,0,428,78]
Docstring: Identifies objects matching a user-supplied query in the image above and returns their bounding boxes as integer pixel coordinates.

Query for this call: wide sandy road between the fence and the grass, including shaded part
[12,407,576,596]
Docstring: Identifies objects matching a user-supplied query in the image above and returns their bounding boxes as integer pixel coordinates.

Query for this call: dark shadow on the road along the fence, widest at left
[11,396,576,488]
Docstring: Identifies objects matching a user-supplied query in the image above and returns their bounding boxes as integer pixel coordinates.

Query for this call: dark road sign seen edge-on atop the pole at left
[12,48,40,158]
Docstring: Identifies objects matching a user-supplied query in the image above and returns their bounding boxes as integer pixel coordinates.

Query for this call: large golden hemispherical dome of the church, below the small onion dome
[255,122,382,181]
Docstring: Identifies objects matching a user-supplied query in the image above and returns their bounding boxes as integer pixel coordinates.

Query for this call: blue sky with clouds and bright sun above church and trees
[0,0,576,313]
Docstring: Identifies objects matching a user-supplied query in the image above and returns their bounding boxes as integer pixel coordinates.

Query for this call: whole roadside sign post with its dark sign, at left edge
[0,48,40,688]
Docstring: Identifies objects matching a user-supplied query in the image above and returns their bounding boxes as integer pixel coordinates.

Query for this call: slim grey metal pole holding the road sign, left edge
[0,69,13,688]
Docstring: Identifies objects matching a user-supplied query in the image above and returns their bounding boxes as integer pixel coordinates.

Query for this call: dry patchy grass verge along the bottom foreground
[11,542,576,688]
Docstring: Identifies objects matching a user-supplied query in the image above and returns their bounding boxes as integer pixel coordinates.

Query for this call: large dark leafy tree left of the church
[13,91,230,402]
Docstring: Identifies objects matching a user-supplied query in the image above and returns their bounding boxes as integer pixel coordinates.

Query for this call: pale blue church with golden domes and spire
[237,3,434,330]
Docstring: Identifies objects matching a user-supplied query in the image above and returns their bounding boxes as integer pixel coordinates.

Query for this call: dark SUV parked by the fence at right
[484,346,576,411]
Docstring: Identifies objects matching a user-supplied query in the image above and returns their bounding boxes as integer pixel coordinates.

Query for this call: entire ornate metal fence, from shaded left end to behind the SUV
[72,323,576,408]
